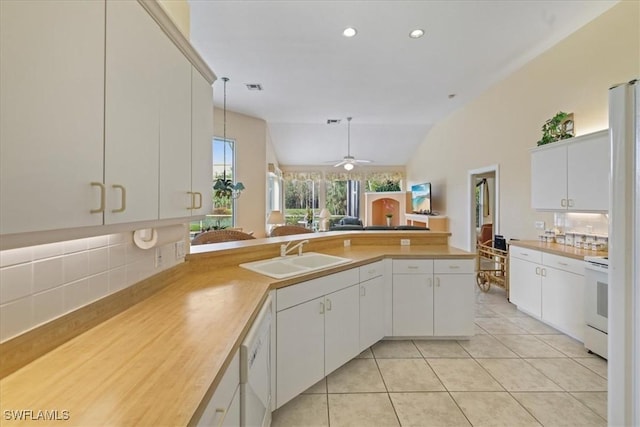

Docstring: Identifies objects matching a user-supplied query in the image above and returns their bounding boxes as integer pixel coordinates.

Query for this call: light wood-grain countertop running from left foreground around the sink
[0,245,475,426]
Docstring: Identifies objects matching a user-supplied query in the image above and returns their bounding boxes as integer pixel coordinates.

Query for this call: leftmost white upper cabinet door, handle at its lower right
[0,0,105,234]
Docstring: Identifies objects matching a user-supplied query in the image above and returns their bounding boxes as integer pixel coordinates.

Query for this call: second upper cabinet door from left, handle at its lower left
[105,1,164,224]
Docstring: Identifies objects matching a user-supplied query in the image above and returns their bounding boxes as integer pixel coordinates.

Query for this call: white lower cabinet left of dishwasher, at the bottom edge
[196,351,240,427]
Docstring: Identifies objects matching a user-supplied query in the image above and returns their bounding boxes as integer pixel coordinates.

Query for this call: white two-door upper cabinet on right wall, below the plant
[531,130,610,212]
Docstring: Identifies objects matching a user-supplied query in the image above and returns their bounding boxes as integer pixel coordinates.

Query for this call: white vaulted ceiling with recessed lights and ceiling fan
[190,0,616,165]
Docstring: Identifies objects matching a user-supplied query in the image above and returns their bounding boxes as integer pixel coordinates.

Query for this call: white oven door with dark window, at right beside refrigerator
[584,263,609,333]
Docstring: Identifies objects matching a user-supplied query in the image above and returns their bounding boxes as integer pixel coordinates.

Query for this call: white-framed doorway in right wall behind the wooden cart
[468,165,500,252]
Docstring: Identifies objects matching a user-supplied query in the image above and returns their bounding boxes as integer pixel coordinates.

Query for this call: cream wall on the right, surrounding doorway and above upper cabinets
[407,1,640,248]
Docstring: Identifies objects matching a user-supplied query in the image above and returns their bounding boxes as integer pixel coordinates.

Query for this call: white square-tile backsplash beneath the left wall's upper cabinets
[0,232,184,342]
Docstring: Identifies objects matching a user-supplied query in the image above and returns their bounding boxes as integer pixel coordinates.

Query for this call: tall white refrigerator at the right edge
[608,80,640,426]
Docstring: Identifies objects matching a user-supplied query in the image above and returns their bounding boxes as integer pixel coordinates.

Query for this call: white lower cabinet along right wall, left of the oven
[509,246,584,341]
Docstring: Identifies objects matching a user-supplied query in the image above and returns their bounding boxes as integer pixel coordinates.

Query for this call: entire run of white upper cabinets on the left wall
[0,0,215,242]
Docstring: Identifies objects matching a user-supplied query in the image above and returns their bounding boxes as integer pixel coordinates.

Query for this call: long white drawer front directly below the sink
[276,268,360,311]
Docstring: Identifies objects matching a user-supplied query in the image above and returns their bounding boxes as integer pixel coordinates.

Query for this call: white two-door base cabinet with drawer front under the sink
[276,269,359,408]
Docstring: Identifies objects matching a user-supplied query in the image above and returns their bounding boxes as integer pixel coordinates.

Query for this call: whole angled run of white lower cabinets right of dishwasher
[275,259,475,408]
